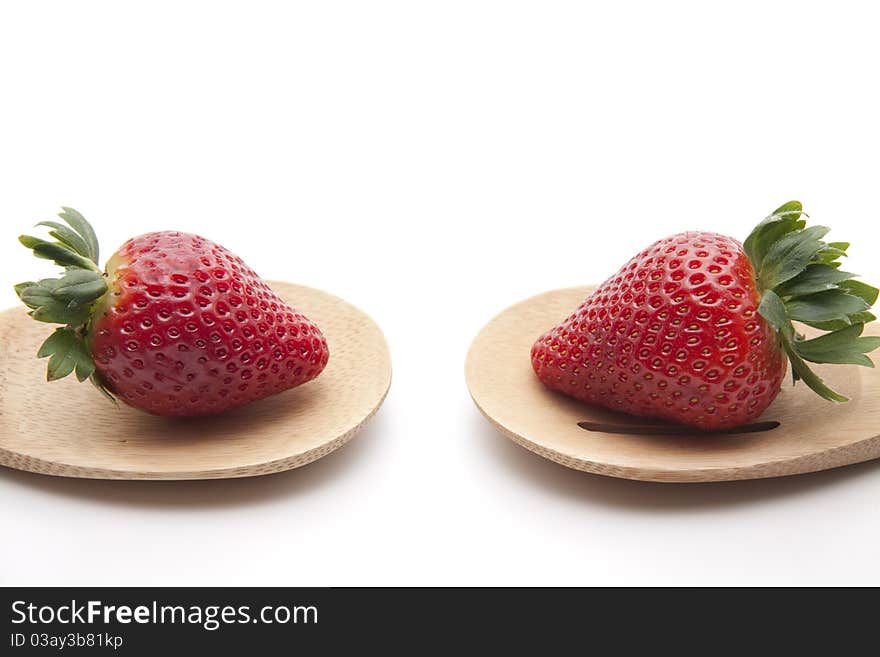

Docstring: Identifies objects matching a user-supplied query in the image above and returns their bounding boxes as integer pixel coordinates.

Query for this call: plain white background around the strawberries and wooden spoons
[0,0,880,585]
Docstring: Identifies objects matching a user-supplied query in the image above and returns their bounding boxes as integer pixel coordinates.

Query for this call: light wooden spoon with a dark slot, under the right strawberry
[465,287,880,482]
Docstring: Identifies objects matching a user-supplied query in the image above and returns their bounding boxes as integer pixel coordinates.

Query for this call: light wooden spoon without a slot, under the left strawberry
[0,282,391,479]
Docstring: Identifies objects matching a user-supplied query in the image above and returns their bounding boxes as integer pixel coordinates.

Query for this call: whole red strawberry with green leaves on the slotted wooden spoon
[531,201,880,430]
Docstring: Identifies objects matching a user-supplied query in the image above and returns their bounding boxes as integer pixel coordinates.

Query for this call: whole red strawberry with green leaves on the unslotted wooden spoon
[15,208,329,416]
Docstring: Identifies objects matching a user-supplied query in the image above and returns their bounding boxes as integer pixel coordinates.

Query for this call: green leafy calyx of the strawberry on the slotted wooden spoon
[743,201,880,402]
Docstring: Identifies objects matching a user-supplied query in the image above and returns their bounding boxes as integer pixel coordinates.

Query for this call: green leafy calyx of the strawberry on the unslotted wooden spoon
[15,208,115,401]
